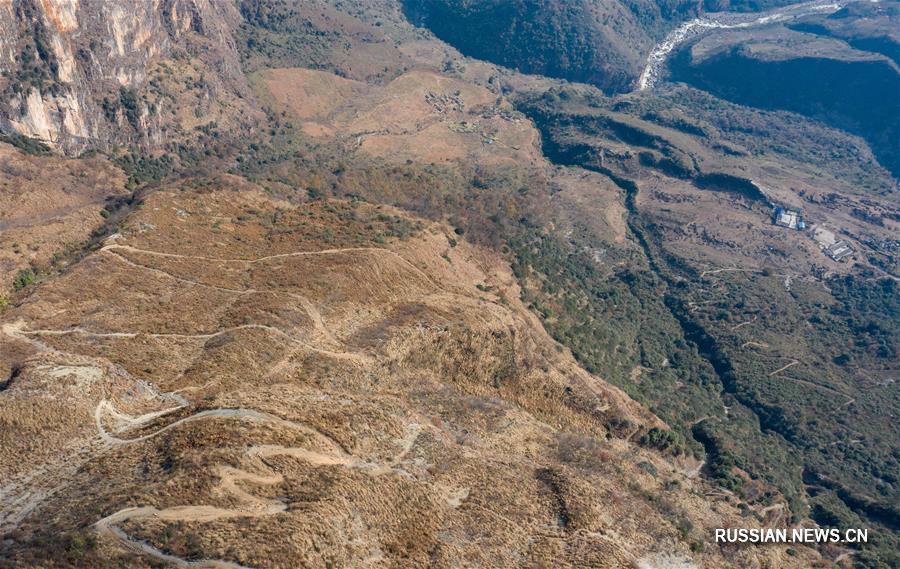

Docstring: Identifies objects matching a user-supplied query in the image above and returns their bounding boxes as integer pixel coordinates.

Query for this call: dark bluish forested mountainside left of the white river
[404,0,696,92]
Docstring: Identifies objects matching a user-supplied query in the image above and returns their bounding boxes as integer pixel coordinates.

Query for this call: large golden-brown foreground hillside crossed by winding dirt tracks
[0,178,824,567]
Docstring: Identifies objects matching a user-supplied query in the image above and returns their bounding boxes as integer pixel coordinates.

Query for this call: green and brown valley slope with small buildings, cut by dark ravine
[523,87,900,567]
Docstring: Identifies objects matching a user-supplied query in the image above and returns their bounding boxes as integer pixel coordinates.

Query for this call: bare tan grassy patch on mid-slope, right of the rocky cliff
[255,68,543,165]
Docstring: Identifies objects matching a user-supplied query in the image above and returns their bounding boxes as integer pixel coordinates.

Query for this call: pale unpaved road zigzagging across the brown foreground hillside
[0,243,430,569]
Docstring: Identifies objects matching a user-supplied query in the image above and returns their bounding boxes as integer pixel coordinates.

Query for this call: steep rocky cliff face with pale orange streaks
[0,0,255,153]
